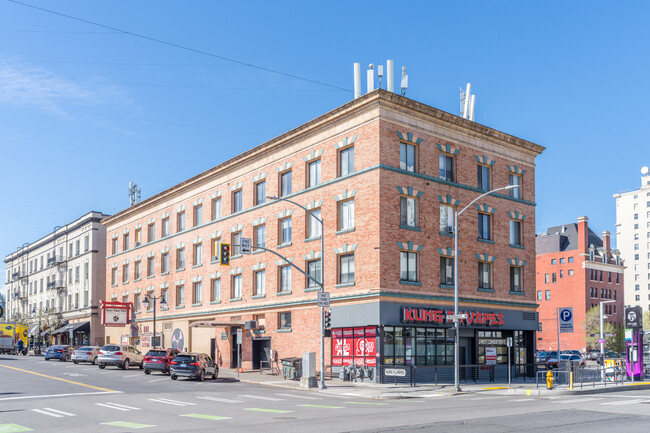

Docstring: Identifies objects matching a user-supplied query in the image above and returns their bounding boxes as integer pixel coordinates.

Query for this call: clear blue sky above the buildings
[0,0,650,294]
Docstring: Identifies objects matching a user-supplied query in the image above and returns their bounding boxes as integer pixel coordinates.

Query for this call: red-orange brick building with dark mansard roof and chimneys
[536,217,625,350]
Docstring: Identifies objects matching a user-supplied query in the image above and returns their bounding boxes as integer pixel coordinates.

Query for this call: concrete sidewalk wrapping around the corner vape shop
[219,368,650,400]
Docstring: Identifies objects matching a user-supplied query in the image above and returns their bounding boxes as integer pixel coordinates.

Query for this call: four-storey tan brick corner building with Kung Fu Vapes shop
[104,89,544,369]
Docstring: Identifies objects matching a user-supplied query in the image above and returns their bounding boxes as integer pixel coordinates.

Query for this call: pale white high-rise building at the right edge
[614,167,650,311]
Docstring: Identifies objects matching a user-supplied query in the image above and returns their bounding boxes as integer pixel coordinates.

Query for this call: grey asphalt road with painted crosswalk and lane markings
[0,356,650,433]
